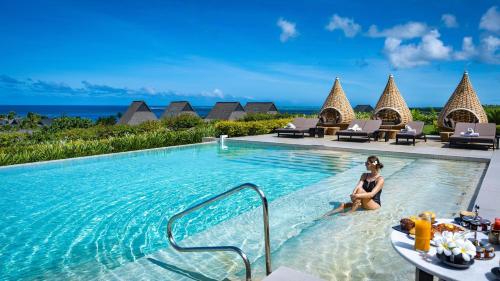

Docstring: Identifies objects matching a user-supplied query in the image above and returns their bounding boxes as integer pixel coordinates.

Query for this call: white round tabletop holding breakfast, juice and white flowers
[391,219,500,281]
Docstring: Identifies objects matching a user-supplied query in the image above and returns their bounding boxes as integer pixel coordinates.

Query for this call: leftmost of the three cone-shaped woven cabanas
[319,77,355,125]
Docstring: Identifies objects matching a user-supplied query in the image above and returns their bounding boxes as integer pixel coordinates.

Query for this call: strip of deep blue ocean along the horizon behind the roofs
[0,105,320,120]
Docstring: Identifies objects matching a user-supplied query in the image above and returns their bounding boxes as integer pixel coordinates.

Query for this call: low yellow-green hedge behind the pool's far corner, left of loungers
[215,118,292,137]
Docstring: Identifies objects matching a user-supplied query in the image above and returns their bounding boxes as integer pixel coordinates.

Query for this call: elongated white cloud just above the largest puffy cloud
[366,22,429,39]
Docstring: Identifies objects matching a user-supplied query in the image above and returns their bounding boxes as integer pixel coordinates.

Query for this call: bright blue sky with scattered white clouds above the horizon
[0,0,500,107]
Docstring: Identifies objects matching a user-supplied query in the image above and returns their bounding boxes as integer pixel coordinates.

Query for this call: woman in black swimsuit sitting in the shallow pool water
[323,156,384,217]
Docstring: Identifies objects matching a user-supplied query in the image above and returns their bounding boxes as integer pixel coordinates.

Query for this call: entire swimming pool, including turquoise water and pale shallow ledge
[0,142,486,280]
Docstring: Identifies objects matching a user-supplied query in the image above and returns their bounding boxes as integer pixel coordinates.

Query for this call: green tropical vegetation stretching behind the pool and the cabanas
[0,106,500,165]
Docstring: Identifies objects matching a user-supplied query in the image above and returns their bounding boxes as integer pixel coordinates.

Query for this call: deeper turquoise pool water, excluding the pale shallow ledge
[0,144,360,279]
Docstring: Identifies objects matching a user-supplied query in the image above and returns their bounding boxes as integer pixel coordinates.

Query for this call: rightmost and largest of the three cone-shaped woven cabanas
[438,71,488,131]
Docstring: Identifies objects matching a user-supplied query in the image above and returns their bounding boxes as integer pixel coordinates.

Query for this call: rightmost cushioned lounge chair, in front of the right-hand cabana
[449,123,496,150]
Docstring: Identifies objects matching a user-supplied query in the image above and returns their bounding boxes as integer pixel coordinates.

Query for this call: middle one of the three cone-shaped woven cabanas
[373,74,413,127]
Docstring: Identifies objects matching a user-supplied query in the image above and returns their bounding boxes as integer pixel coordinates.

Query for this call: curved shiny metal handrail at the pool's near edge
[167,183,272,281]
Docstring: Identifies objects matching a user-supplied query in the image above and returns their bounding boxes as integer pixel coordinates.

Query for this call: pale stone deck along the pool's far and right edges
[229,134,500,219]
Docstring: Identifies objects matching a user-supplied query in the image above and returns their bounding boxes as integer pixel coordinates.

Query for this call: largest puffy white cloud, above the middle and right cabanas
[384,30,452,68]
